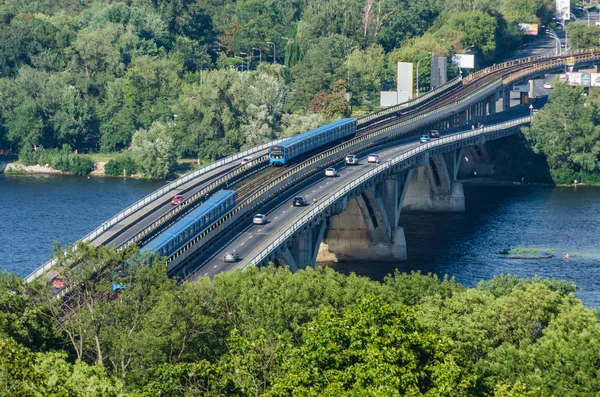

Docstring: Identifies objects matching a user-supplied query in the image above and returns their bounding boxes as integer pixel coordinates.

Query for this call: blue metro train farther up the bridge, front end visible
[269,118,356,166]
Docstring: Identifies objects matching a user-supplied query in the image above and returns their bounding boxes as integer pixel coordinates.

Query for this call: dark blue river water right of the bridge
[334,186,600,307]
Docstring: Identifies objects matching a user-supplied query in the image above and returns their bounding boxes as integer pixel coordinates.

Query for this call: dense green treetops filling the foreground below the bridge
[0,240,600,397]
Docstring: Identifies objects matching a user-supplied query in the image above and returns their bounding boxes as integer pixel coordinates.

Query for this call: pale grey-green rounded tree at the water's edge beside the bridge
[131,122,177,178]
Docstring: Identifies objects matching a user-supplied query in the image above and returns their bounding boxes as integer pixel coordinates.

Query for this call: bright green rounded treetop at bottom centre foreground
[268,297,473,396]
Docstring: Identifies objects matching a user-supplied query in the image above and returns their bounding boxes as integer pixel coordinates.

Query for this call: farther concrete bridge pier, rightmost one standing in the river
[402,150,465,212]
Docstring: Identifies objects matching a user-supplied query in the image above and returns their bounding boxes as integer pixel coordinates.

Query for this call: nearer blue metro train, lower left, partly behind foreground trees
[112,190,236,291]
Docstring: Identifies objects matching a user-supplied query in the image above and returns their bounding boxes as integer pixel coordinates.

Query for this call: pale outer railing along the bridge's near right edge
[240,116,531,269]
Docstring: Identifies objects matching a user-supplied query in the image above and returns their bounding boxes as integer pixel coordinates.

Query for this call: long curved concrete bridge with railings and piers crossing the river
[26,50,600,281]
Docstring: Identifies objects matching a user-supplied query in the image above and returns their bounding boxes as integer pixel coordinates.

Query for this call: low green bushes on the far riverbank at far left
[19,145,94,175]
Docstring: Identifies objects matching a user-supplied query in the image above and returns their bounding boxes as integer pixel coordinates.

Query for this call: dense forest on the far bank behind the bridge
[0,0,553,177]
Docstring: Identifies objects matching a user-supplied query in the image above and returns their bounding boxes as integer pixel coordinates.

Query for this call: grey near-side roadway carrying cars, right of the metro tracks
[189,103,545,280]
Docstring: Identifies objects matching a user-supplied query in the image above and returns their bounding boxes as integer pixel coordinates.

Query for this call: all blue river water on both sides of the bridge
[0,175,600,307]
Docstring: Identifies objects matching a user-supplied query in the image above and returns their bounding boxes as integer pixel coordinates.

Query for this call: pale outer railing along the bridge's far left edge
[25,138,288,282]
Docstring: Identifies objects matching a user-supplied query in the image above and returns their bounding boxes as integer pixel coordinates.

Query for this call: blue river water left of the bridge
[0,174,164,276]
